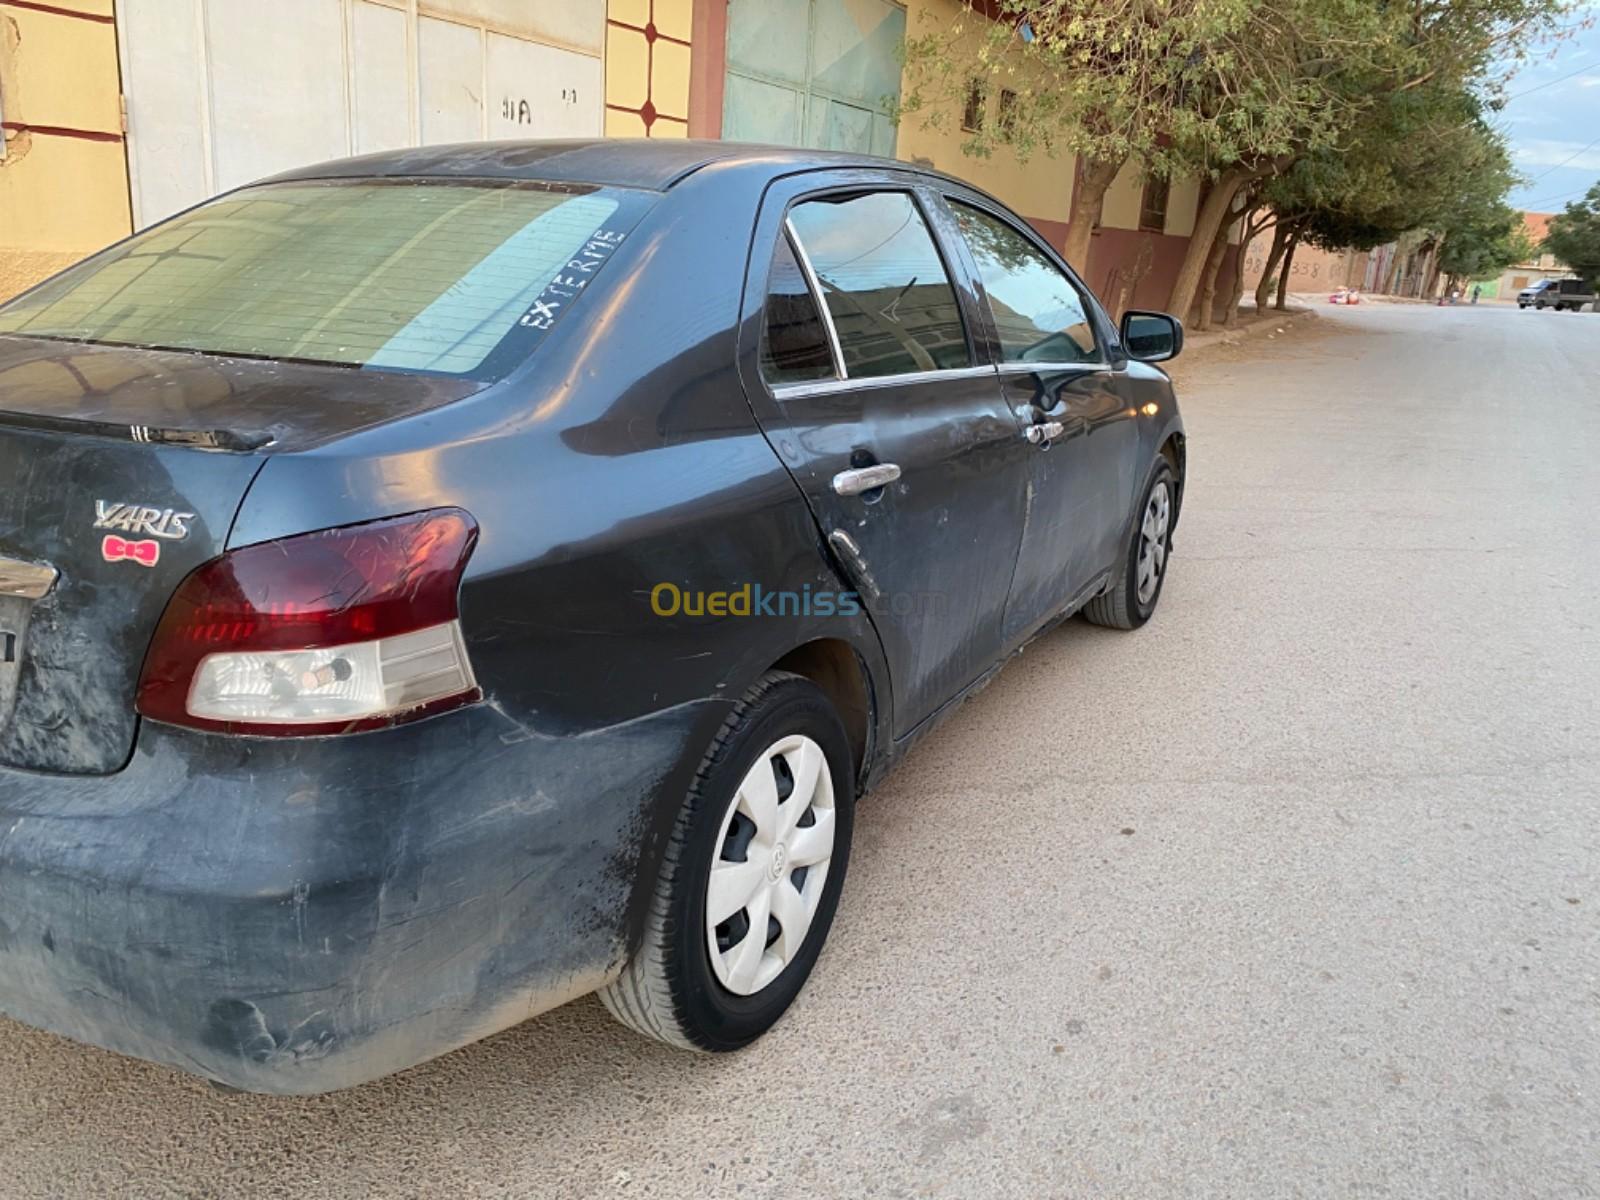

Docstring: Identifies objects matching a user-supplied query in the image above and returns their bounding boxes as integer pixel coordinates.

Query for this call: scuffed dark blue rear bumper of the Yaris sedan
[0,702,725,1094]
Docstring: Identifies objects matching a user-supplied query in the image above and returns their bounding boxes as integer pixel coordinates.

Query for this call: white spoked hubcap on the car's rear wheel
[706,734,834,995]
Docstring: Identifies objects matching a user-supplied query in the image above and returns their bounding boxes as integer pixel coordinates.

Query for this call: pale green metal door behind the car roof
[722,0,906,155]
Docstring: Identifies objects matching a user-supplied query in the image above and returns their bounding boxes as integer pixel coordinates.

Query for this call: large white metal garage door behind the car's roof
[117,0,605,227]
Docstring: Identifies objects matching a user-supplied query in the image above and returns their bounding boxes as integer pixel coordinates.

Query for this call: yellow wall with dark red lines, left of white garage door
[0,0,133,298]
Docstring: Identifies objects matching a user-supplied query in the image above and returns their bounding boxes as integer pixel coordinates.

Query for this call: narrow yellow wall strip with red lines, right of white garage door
[605,0,694,138]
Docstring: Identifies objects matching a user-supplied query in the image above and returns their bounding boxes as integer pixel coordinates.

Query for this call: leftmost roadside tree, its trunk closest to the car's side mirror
[901,0,1355,269]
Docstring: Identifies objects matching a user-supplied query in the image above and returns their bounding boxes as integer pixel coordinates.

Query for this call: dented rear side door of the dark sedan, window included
[741,173,1029,736]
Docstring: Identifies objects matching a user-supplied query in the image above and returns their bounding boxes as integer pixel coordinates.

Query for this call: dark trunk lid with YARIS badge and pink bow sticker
[0,336,482,774]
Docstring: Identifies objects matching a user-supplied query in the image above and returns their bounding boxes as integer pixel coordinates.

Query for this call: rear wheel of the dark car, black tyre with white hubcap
[600,672,854,1051]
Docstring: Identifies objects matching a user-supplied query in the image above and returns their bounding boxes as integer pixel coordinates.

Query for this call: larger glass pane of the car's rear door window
[789,192,973,379]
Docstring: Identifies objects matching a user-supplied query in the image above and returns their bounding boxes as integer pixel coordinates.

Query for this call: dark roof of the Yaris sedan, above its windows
[266,138,962,192]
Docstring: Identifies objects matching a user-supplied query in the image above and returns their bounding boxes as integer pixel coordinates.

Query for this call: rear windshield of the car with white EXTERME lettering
[0,179,650,378]
